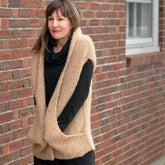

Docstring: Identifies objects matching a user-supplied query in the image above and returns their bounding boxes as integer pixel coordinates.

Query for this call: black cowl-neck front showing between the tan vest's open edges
[44,39,71,106]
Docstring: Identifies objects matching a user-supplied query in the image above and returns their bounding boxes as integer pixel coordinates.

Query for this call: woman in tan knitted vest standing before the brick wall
[28,0,96,165]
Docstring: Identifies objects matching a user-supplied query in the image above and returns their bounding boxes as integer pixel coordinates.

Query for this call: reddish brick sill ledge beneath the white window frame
[126,52,165,67]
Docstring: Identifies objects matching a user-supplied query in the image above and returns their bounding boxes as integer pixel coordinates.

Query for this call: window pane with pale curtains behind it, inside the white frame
[127,2,152,39]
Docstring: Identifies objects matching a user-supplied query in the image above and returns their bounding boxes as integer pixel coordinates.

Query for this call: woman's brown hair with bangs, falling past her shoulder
[32,0,81,52]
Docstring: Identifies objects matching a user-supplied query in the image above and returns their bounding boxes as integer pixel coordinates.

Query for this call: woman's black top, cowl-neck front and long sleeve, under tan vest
[44,39,93,132]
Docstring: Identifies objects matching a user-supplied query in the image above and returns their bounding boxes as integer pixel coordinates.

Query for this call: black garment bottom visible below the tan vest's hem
[34,150,95,165]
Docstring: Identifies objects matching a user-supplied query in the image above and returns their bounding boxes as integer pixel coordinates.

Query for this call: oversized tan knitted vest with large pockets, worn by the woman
[28,28,96,160]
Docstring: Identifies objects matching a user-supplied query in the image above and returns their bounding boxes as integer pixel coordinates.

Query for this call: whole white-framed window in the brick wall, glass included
[126,0,159,55]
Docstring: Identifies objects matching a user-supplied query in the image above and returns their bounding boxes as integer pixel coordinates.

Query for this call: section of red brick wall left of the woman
[0,0,46,165]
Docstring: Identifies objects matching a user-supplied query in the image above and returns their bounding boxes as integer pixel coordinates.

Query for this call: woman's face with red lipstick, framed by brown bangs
[48,10,73,40]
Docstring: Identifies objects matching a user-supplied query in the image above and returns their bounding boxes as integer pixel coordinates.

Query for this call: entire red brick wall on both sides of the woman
[0,0,165,165]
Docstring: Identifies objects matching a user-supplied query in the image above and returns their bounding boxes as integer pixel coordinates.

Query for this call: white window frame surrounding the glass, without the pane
[126,0,160,55]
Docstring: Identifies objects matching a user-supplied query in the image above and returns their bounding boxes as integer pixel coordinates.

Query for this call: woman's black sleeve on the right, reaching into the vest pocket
[58,60,93,132]
